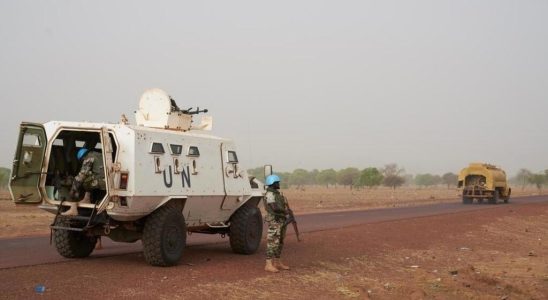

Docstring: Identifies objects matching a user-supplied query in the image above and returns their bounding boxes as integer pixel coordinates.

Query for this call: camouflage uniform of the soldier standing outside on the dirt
[264,187,287,259]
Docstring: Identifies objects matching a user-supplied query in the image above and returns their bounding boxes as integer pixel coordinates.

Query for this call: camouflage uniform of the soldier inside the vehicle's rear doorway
[70,151,106,197]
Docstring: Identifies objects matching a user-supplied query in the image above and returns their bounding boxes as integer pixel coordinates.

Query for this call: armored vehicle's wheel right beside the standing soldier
[229,205,263,254]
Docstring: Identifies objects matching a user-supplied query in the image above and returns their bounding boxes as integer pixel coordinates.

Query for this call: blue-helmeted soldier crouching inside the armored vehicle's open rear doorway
[63,148,106,216]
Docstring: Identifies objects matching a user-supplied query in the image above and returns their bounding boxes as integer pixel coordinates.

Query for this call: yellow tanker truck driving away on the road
[458,163,512,204]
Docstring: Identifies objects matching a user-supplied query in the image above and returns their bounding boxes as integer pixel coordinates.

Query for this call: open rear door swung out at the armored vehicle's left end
[10,123,47,204]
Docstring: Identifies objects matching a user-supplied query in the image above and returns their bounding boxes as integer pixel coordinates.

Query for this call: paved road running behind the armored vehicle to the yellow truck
[0,196,548,269]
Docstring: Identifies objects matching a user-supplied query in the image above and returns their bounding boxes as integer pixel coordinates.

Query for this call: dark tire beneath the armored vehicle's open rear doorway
[53,219,97,258]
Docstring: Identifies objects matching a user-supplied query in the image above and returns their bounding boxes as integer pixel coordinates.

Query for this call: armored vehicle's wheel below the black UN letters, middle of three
[142,206,186,267]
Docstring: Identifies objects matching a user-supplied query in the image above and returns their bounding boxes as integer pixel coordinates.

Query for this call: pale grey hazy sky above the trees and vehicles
[0,0,548,173]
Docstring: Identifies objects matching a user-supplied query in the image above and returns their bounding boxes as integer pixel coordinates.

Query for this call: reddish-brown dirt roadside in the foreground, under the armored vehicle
[0,195,548,299]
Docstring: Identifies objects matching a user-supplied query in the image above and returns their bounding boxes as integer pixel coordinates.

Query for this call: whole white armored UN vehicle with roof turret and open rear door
[10,89,264,266]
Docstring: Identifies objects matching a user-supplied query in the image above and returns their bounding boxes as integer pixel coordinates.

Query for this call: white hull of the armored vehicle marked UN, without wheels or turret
[40,121,264,227]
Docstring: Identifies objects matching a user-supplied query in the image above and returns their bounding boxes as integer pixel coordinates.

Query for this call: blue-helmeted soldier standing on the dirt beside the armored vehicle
[264,174,289,272]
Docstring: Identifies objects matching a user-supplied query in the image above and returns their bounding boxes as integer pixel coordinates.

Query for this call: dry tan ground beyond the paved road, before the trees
[0,186,538,238]
